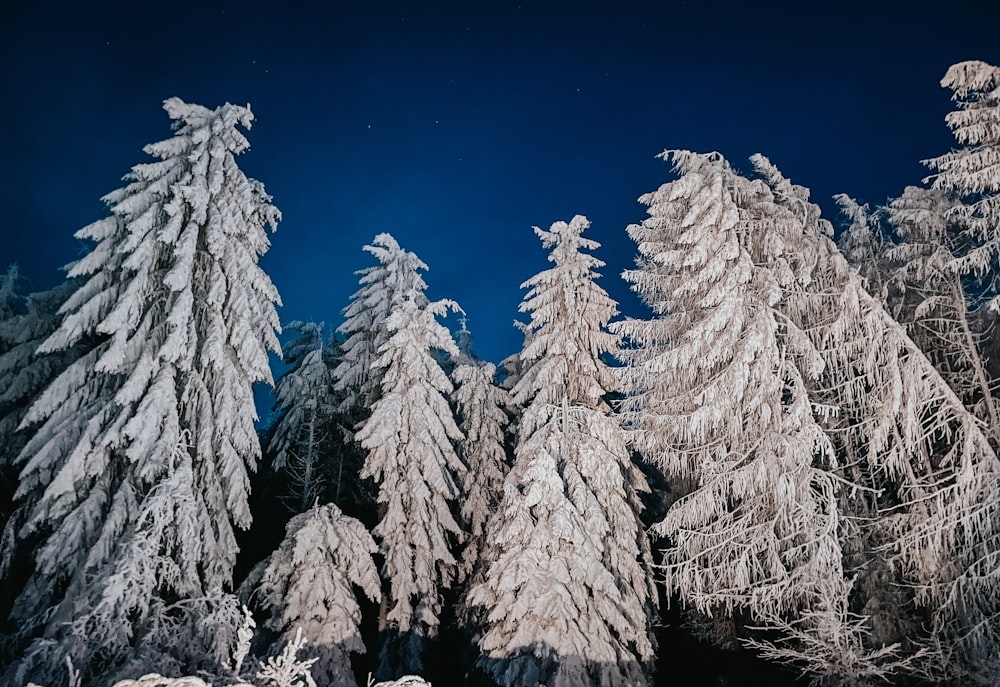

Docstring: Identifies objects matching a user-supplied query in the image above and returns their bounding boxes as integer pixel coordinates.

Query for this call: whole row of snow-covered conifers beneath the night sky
[0,62,1000,687]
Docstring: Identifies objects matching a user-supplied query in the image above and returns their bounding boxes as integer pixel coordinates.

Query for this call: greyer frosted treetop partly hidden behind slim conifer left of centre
[334,233,427,413]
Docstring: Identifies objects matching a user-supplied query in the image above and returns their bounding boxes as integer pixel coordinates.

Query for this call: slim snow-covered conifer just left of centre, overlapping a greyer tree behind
[354,234,466,677]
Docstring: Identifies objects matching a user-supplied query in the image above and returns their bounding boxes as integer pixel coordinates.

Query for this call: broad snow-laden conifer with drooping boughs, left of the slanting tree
[615,151,880,678]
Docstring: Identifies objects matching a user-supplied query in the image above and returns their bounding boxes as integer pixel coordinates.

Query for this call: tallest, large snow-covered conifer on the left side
[4,98,280,682]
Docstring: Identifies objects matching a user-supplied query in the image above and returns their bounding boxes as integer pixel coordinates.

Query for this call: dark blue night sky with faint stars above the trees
[0,0,1000,361]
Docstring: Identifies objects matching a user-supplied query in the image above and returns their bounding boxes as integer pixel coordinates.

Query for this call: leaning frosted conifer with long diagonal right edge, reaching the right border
[753,150,1000,684]
